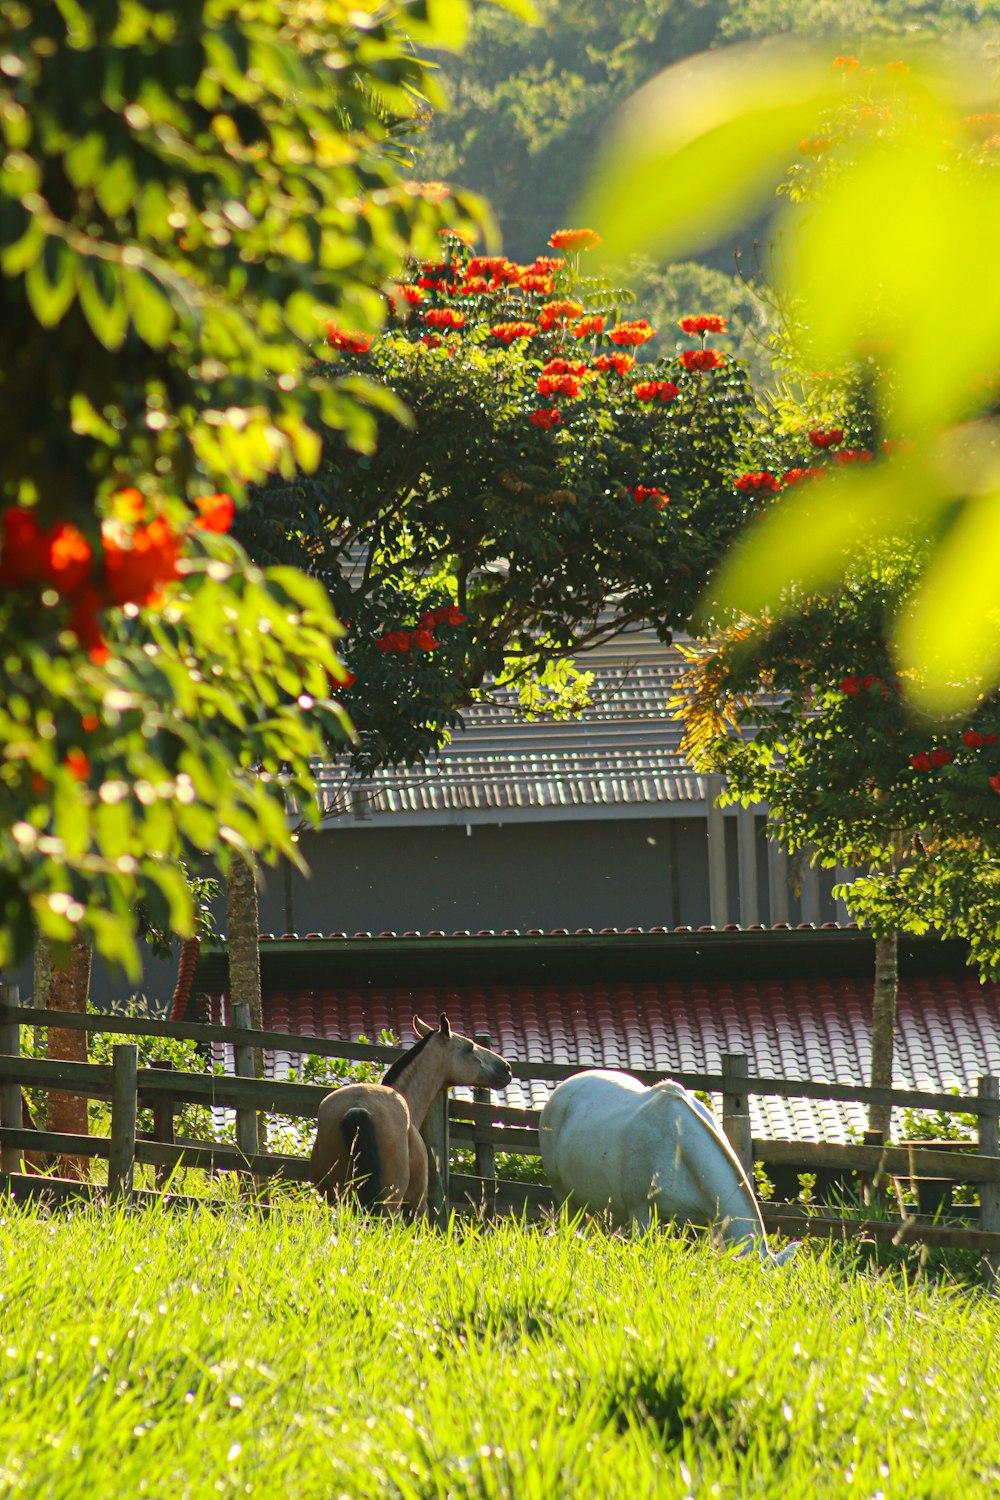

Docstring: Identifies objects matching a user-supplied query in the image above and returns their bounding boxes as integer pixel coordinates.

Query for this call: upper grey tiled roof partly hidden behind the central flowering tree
[319,630,705,821]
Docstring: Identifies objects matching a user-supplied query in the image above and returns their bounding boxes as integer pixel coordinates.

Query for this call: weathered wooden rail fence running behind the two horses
[0,987,1000,1277]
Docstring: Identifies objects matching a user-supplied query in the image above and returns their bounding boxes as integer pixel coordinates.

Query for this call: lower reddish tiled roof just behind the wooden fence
[209,974,1000,1143]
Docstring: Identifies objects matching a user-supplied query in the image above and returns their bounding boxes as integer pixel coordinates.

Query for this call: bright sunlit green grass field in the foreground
[0,1200,1000,1500]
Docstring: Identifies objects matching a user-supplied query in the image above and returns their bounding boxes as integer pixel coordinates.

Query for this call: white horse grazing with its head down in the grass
[538,1068,796,1265]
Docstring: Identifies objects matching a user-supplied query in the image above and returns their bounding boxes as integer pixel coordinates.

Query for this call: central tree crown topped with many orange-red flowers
[238,230,760,771]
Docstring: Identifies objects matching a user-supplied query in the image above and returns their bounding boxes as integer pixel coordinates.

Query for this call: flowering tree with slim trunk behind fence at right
[676,546,1000,1133]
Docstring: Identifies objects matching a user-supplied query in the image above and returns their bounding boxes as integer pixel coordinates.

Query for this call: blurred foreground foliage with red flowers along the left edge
[0,0,497,969]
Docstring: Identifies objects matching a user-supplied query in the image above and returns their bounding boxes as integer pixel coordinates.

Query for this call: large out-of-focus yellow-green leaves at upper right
[589,44,1000,713]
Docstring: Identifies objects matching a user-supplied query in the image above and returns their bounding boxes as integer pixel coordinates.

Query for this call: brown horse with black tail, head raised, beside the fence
[310,1016,511,1214]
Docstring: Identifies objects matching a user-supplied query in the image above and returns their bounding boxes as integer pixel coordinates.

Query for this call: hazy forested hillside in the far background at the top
[420,0,1000,375]
